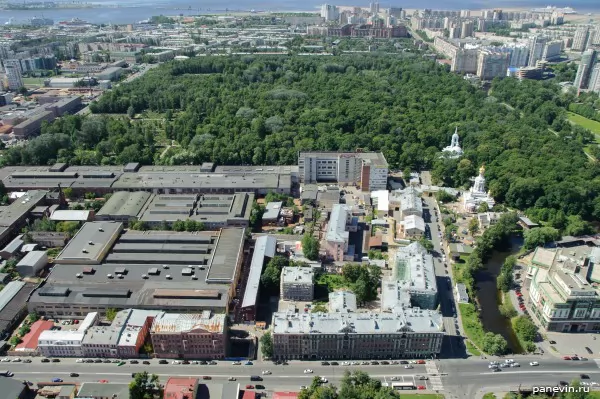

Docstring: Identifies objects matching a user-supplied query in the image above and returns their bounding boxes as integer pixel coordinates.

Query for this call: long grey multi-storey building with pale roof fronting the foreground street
[272,309,444,359]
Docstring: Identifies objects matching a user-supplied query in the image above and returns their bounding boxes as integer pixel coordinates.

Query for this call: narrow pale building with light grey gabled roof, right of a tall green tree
[325,204,358,261]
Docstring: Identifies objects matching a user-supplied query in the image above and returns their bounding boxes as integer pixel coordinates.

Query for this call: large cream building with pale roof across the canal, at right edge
[527,245,600,332]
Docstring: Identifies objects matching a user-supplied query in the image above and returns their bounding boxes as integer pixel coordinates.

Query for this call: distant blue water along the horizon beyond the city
[0,0,600,24]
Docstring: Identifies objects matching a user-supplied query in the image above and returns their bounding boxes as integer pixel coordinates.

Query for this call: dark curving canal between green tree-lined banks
[475,236,523,353]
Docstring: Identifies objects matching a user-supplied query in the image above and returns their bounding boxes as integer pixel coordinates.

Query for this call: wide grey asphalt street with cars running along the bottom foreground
[0,356,600,398]
